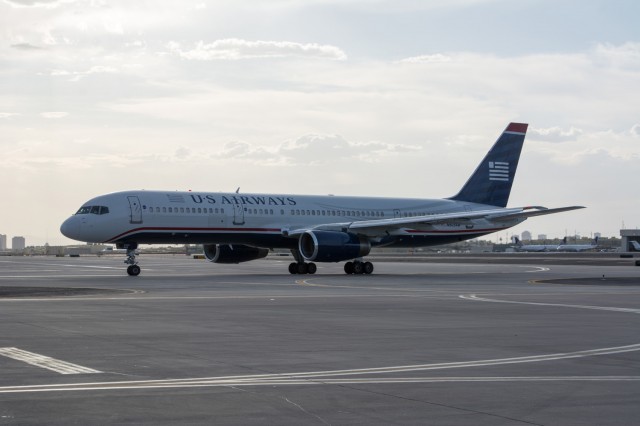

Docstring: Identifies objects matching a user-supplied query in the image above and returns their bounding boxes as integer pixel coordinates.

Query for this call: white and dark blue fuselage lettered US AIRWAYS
[61,191,524,248]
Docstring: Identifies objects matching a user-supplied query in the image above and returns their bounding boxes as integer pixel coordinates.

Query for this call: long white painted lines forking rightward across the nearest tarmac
[0,344,640,393]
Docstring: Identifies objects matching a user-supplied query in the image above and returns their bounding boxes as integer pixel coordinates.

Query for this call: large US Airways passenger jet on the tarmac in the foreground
[60,123,584,276]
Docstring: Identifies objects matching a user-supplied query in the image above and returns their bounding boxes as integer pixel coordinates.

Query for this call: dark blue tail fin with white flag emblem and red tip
[450,123,528,207]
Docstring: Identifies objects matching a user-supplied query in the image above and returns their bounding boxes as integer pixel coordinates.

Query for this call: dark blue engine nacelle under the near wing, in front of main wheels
[298,231,371,262]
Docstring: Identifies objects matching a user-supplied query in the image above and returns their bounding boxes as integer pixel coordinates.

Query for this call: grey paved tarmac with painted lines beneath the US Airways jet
[0,254,640,426]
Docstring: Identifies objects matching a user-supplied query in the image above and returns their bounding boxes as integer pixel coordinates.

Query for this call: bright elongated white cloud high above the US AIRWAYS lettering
[167,38,347,61]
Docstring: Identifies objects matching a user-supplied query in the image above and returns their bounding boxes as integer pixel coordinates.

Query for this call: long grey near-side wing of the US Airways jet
[285,206,584,237]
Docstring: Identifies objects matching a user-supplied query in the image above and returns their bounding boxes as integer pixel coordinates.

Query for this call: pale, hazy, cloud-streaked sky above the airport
[0,0,640,245]
